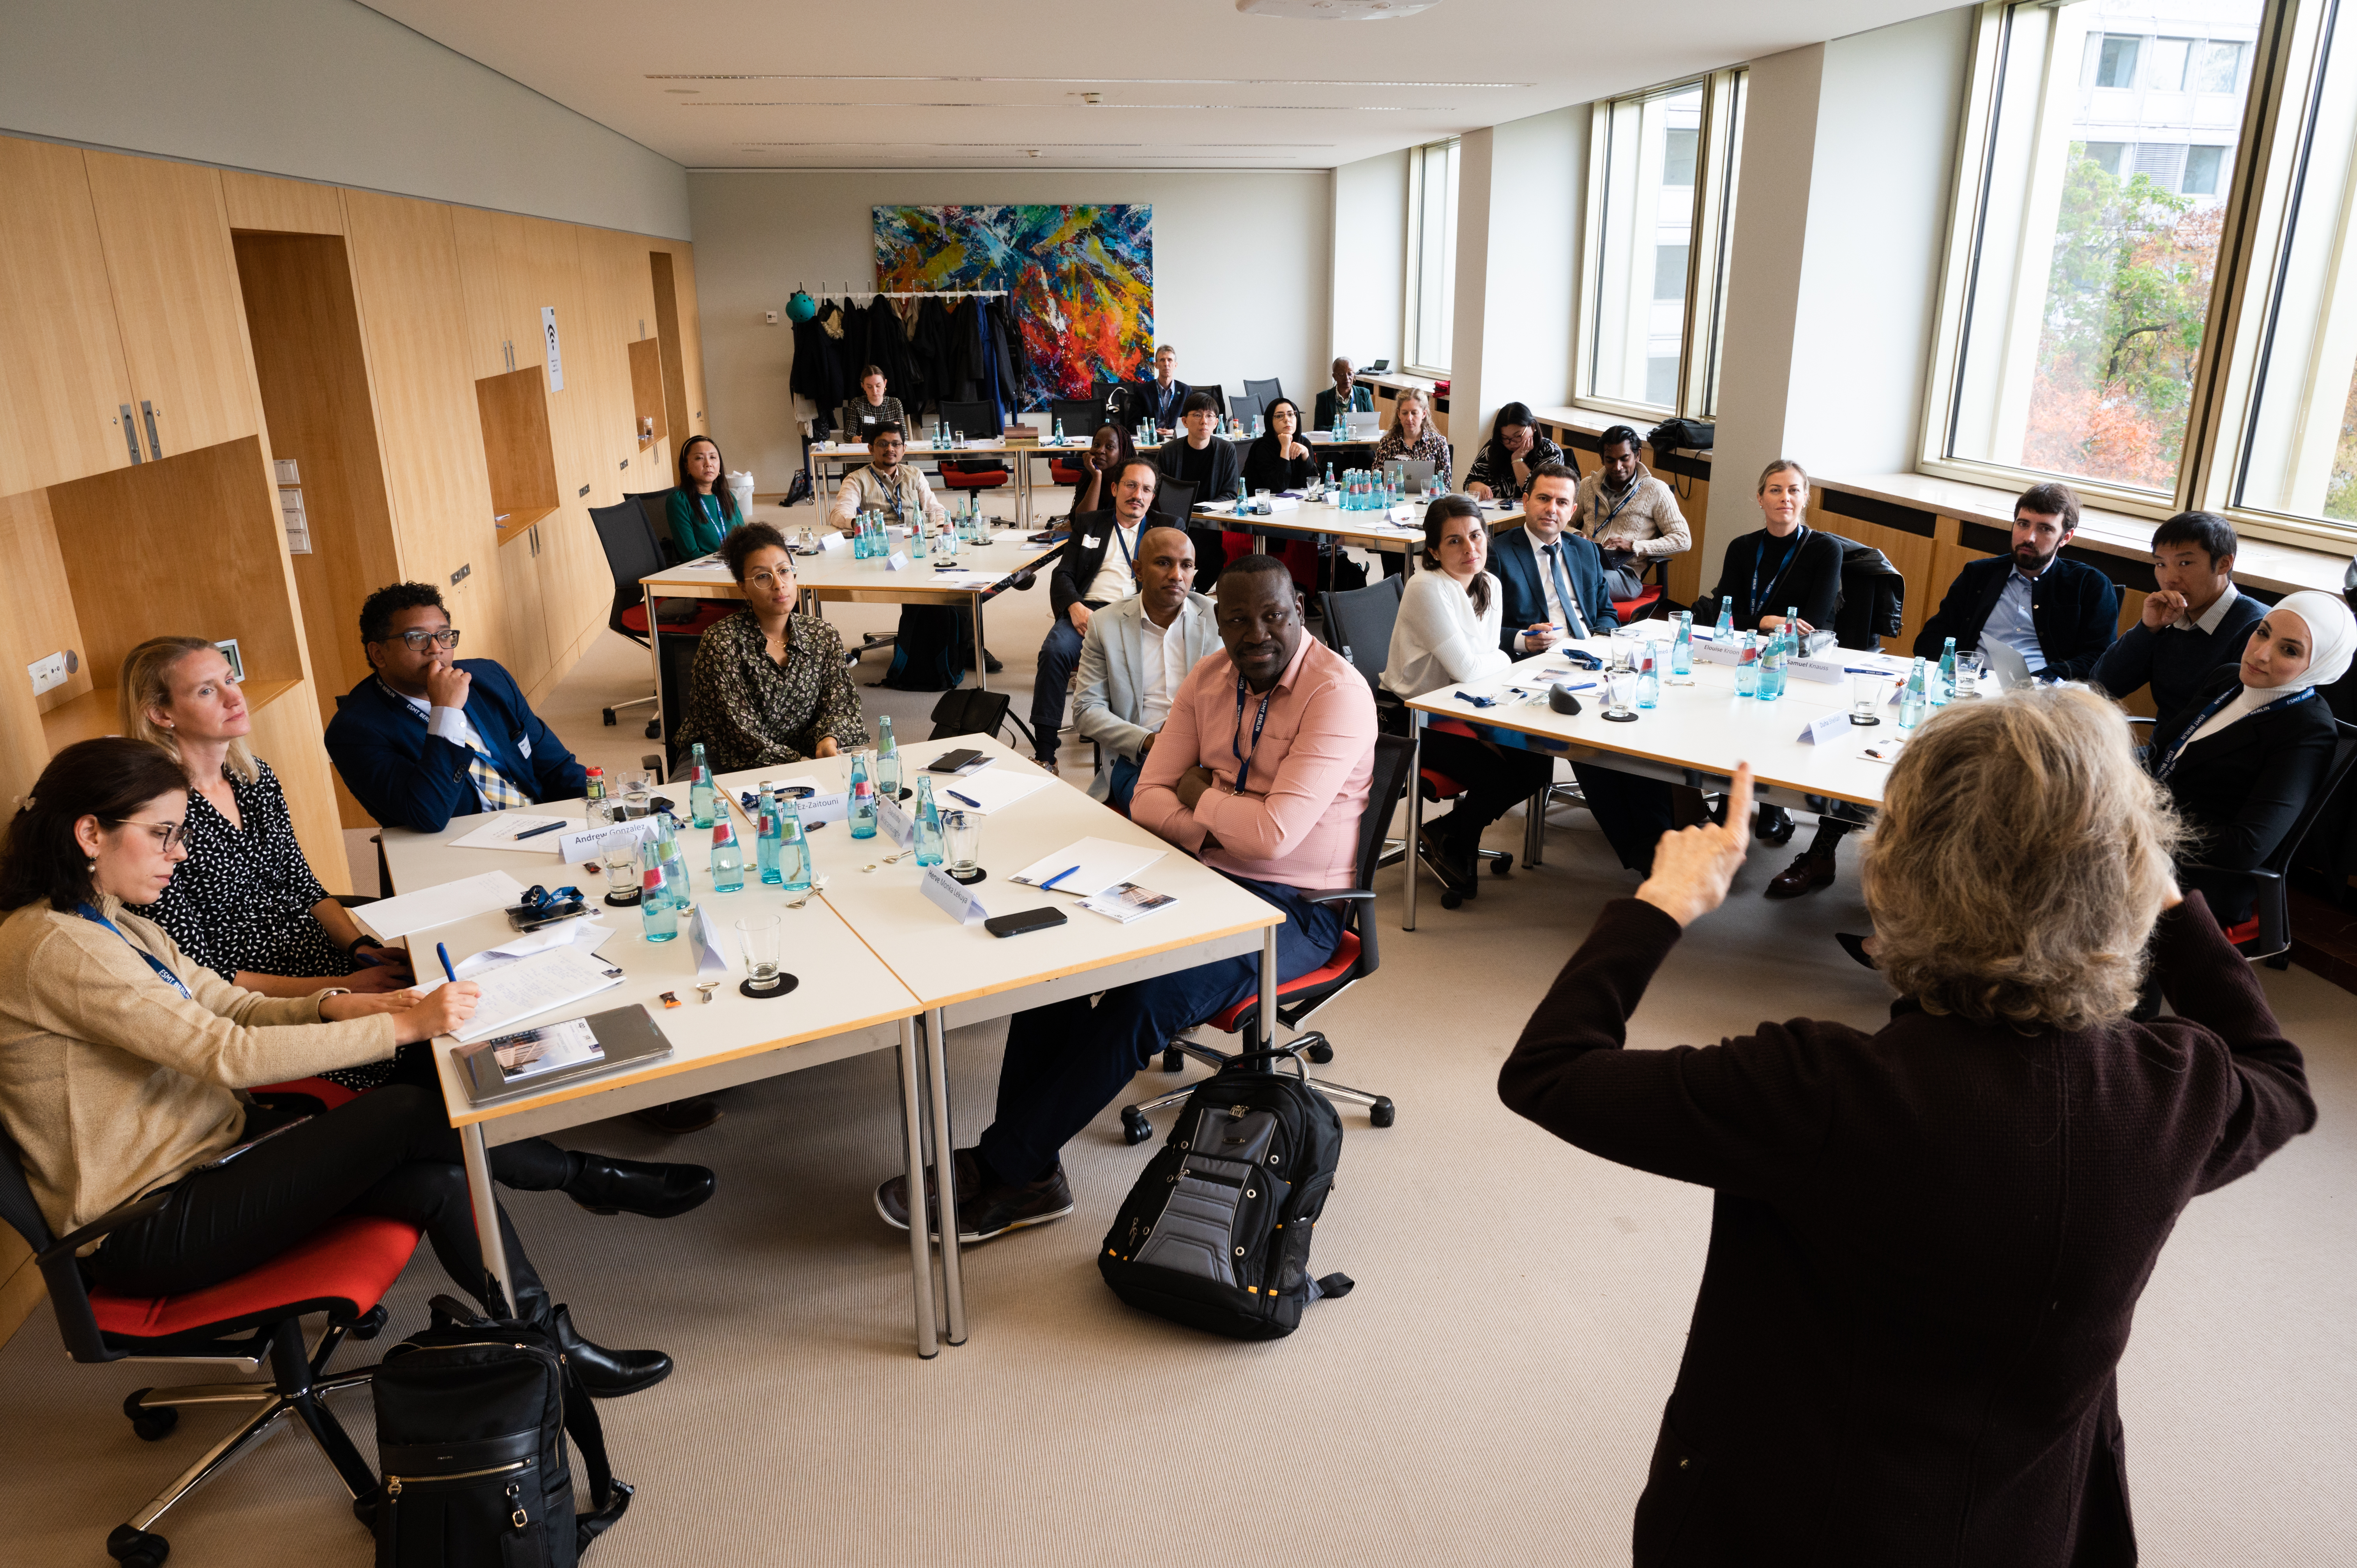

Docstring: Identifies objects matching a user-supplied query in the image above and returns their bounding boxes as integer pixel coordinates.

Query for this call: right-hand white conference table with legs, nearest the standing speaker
[1403,620,1909,931]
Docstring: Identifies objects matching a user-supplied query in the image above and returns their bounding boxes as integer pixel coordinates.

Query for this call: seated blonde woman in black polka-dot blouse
[118,637,412,1089]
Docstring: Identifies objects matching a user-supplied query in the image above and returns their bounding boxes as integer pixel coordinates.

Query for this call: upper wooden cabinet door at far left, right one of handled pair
[83,153,261,460]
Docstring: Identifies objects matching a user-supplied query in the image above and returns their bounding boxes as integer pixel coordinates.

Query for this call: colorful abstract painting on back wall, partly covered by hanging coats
[875,203,1155,408]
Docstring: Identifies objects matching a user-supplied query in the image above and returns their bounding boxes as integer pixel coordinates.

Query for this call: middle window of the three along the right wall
[1577,71,1744,413]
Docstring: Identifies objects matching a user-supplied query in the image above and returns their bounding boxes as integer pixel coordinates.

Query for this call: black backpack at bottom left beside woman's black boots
[370,1297,632,1568]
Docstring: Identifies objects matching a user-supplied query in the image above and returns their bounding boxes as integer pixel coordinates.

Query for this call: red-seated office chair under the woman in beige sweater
[0,1132,420,1568]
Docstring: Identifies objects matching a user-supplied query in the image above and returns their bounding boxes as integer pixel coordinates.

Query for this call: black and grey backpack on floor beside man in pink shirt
[1096,1054,1351,1339]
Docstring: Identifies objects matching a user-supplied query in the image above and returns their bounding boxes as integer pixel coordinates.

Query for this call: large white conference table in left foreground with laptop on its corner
[384,736,1285,1356]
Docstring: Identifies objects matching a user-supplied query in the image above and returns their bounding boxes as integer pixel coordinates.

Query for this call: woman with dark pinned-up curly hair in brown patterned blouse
[679,523,868,773]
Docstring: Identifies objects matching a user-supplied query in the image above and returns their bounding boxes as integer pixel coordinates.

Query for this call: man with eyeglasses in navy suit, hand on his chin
[328,583,589,832]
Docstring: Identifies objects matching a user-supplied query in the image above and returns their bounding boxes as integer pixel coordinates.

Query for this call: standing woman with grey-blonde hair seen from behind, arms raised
[1499,686,2315,1566]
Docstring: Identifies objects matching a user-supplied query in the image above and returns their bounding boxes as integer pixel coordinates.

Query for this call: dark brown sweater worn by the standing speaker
[1499,893,2317,1568]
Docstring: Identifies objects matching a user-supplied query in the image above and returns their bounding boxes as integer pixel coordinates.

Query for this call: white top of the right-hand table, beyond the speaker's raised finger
[1410,622,1900,806]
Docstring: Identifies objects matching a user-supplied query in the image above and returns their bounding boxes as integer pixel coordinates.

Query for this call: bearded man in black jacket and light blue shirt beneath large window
[1916,483,2119,682]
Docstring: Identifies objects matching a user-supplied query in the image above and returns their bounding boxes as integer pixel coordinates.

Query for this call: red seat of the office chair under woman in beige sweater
[90,1217,417,1339]
